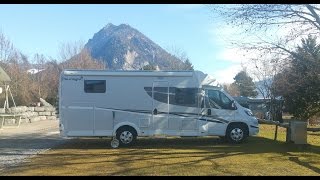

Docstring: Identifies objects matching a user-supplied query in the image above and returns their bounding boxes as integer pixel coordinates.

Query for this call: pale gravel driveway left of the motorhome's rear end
[0,120,67,172]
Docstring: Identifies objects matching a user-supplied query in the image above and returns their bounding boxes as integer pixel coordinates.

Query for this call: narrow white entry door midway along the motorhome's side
[152,81,169,134]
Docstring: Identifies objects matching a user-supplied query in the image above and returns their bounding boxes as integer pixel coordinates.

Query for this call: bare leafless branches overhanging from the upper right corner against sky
[209,4,320,64]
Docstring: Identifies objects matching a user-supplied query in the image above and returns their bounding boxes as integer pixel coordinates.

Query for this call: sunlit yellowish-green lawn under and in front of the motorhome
[2,125,320,176]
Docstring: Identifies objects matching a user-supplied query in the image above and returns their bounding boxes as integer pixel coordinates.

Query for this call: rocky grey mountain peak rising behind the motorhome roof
[85,23,183,70]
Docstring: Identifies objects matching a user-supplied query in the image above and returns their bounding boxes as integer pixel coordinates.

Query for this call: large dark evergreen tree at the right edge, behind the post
[273,36,320,119]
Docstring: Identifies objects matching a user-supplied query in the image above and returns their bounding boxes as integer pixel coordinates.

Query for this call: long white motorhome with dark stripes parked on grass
[59,70,259,147]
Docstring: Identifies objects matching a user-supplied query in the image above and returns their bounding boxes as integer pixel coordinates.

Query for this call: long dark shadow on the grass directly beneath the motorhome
[48,136,320,153]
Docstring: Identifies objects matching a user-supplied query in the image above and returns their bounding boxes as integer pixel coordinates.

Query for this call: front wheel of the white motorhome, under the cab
[226,123,249,144]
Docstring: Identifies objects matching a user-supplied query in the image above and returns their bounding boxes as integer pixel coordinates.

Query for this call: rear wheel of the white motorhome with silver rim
[116,126,137,146]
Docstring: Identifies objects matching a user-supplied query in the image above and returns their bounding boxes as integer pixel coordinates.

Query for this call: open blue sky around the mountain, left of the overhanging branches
[0,4,248,83]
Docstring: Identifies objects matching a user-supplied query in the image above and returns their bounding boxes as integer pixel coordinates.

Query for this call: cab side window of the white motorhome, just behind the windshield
[206,90,232,109]
